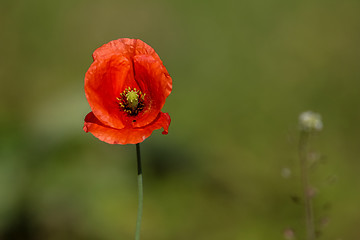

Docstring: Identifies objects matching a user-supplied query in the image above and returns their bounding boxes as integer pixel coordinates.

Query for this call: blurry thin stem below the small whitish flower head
[299,132,315,240]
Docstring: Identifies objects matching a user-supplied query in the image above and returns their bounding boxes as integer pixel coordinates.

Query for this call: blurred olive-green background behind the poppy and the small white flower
[0,0,360,240]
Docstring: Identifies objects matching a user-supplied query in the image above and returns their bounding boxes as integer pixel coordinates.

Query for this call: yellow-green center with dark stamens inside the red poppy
[116,87,145,116]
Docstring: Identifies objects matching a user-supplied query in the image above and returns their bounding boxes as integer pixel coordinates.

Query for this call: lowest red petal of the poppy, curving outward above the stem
[84,112,171,144]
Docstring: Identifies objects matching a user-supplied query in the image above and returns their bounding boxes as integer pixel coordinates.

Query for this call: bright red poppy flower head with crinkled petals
[84,38,172,144]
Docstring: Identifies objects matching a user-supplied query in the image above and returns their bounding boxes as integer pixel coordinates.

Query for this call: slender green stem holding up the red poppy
[135,143,144,240]
